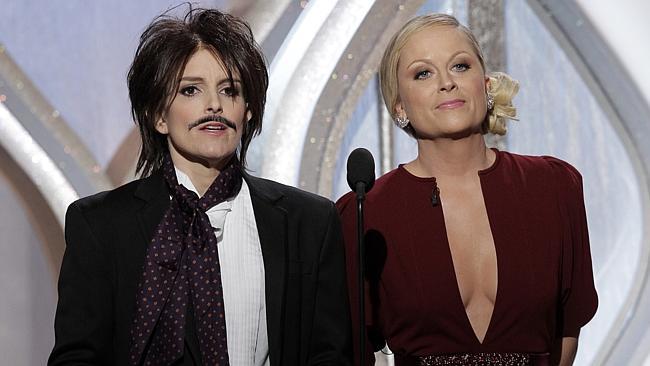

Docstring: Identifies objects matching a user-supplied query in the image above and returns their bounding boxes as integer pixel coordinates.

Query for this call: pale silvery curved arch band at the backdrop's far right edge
[527,0,650,365]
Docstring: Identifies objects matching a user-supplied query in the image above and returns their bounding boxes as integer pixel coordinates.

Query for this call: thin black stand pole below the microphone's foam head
[355,182,366,366]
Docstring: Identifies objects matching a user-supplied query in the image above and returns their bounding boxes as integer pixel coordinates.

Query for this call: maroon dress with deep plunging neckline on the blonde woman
[337,150,598,364]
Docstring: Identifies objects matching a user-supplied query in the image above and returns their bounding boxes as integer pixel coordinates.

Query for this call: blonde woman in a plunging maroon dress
[337,14,598,366]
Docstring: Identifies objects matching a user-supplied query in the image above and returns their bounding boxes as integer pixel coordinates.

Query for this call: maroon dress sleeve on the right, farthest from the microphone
[548,158,598,337]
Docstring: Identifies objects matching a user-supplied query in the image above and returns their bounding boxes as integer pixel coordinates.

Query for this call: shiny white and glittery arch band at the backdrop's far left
[0,45,110,272]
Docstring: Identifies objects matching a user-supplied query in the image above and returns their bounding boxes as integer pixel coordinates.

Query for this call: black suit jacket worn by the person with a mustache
[48,173,351,366]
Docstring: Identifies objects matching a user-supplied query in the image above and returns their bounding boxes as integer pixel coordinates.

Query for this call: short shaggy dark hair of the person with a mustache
[127,6,269,176]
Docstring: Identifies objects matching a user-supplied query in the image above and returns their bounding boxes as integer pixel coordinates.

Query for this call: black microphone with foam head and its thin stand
[347,148,375,366]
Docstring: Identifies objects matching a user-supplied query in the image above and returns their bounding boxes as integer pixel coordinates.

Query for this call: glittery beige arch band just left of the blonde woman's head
[297,0,424,197]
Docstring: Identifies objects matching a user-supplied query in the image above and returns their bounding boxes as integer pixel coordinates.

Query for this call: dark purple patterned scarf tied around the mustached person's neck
[130,155,242,366]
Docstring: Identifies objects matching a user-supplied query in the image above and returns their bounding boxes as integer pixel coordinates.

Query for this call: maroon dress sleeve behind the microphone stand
[336,192,384,366]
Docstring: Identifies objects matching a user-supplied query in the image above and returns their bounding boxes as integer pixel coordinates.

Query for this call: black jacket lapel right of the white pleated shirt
[244,174,289,365]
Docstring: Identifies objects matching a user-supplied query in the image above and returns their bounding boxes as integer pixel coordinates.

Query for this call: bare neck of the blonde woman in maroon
[406,134,496,177]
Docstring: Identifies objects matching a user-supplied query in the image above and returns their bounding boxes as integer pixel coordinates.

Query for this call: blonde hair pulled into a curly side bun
[379,14,519,136]
